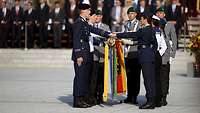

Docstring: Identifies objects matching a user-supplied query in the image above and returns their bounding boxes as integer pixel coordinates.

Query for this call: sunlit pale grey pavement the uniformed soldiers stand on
[0,51,200,113]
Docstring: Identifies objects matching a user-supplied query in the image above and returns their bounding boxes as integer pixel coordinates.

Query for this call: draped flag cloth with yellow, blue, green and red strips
[103,40,127,102]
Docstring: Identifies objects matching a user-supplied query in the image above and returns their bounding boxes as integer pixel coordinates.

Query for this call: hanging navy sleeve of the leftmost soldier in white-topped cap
[73,22,82,58]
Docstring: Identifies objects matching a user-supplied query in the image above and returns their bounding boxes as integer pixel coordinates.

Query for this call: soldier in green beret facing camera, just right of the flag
[120,7,141,104]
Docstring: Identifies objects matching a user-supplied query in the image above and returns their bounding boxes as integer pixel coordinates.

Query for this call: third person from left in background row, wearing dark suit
[25,2,36,48]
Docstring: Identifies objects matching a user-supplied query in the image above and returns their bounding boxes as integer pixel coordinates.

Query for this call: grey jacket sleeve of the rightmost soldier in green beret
[170,24,177,58]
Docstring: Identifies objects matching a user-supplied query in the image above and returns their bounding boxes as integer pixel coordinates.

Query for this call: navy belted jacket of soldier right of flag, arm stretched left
[117,26,158,63]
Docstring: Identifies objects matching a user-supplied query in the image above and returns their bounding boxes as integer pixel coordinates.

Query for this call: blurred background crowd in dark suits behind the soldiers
[0,0,200,48]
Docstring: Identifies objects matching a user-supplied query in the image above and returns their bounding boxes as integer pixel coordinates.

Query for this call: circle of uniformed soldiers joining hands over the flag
[72,3,177,109]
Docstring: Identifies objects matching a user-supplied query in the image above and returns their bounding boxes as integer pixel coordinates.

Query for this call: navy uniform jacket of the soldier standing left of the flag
[72,17,109,62]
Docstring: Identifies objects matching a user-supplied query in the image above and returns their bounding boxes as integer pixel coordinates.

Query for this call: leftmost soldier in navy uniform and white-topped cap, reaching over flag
[72,4,110,108]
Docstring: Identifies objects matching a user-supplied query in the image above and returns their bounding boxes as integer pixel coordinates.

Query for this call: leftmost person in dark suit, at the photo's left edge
[0,0,10,48]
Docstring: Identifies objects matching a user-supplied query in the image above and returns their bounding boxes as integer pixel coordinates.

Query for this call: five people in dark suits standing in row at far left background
[0,0,65,48]
